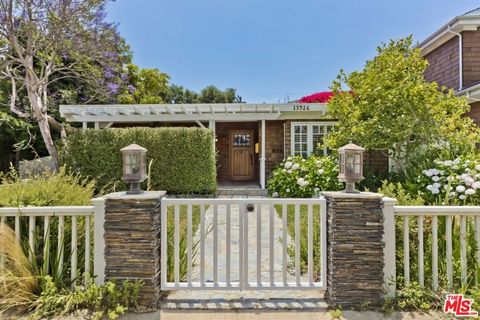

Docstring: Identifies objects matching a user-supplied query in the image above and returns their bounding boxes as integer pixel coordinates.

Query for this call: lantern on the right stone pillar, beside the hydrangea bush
[338,142,365,193]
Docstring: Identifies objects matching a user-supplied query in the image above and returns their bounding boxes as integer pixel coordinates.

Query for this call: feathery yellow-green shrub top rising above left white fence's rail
[0,168,95,207]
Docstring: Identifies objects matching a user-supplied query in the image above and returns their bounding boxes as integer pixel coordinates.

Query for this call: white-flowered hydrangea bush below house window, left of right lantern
[267,155,343,198]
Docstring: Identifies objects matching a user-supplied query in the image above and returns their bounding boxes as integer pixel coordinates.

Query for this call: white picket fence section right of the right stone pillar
[384,198,480,290]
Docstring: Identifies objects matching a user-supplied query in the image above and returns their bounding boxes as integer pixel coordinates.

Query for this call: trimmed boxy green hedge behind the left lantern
[58,127,217,194]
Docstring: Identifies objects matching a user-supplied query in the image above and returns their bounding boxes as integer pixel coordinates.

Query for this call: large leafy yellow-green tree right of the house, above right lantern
[327,37,479,164]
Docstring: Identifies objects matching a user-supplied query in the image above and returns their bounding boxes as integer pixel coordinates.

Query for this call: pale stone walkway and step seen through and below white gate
[166,199,323,307]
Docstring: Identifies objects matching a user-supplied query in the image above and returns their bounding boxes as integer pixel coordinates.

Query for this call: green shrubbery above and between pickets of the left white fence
[0,168,95,288]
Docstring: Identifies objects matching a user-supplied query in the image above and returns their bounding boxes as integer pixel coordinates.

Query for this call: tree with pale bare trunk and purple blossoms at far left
[0,0,121,168]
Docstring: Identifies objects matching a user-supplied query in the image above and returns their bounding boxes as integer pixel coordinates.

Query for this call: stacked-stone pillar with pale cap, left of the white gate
[103,191,165,306]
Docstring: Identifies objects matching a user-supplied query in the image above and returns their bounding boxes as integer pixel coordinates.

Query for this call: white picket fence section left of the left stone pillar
[0,206,94,286]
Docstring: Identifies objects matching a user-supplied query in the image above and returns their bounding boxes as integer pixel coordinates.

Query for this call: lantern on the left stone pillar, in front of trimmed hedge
[120,143,147,194]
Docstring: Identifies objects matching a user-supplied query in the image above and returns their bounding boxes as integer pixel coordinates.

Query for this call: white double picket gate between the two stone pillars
[160,198,327,290]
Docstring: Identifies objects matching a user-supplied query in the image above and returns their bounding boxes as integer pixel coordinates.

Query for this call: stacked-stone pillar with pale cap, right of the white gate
[323,192,385,309]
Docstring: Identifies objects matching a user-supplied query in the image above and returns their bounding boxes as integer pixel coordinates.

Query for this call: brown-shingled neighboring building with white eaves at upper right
[419,8,480,125]
